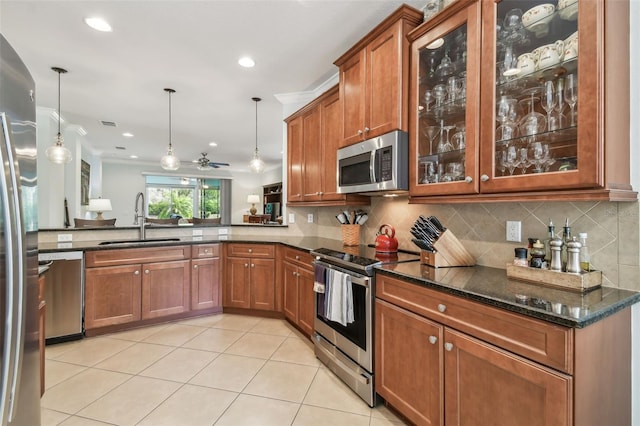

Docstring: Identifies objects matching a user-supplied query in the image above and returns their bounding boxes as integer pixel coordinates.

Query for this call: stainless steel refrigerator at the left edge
[0,34,40,426]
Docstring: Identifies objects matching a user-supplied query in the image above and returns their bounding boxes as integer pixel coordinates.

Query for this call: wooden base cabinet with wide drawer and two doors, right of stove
[375,274,631,425]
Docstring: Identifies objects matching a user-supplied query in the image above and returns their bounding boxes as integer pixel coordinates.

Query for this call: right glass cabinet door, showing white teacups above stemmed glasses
[480,0,597,192]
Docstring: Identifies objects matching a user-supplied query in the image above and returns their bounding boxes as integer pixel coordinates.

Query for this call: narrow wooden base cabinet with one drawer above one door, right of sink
[191,244,222,311]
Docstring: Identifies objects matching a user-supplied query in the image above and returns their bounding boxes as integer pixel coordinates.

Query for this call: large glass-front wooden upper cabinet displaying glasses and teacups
[409,0,637,203]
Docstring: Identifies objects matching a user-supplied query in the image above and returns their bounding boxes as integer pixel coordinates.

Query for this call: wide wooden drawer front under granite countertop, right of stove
[376,274,573,373]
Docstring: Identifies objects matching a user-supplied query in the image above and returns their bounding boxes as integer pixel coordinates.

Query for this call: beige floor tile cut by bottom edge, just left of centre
[216,395,299,426]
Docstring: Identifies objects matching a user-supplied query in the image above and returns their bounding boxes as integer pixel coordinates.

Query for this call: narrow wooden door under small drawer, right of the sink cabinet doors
[191,257,221,310]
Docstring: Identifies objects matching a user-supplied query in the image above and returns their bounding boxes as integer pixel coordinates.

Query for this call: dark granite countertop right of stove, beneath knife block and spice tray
[376,262,640,328]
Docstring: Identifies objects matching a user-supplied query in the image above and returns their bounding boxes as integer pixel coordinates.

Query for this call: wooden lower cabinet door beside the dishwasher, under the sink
[84,265,142,330]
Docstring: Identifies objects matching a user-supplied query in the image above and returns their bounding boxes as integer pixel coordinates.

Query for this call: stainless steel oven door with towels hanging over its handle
[314,261,373,372]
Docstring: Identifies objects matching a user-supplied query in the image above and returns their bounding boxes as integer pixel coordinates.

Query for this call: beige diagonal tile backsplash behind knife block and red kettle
[288,197,640,291]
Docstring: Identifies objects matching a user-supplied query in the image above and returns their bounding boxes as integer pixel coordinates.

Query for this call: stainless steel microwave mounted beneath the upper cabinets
[338,130,409,195]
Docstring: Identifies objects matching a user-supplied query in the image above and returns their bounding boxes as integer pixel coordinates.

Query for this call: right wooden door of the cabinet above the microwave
[363,21,408,139]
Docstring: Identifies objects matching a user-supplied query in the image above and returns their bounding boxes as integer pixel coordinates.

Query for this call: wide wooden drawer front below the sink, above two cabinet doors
[84,246,191,268]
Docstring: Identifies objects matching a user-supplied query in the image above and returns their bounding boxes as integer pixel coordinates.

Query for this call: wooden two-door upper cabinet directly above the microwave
[334,5,423,147]
